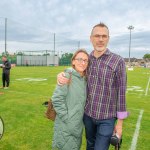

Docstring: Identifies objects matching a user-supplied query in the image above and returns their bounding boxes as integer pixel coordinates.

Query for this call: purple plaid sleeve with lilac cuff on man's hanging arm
[117,59,128,119]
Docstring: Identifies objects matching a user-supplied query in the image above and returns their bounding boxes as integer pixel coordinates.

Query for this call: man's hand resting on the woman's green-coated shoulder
[57,72,69,85]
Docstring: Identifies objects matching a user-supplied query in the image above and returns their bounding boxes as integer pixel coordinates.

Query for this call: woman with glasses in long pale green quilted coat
[52,49,89,150]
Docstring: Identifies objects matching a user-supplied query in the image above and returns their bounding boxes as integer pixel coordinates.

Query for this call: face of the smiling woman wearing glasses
[72,52,89,74]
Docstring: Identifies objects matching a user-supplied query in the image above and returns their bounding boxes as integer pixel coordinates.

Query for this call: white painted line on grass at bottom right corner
[129,109,144,150]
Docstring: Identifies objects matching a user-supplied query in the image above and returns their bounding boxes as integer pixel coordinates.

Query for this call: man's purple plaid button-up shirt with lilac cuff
[85,49,128,120]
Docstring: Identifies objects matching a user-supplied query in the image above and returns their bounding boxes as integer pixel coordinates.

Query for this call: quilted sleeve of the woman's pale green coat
[51,85,68,122]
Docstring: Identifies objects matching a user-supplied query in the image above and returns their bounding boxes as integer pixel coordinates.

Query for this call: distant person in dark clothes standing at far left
[1,56,11,89]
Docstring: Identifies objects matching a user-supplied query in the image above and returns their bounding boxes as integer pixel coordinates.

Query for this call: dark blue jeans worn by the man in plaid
[83,114,116,150]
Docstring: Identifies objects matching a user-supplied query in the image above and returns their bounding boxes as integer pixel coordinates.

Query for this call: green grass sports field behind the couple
[0,67,150,150]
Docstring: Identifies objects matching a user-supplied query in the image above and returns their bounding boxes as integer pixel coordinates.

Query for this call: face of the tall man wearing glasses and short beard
[90,27,109,52]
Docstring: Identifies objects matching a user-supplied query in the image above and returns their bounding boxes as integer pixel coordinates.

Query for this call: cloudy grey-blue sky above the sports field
[0,0,150,58]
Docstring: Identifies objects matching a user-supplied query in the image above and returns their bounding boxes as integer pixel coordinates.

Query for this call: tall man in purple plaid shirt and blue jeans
[58,23,128,150]
